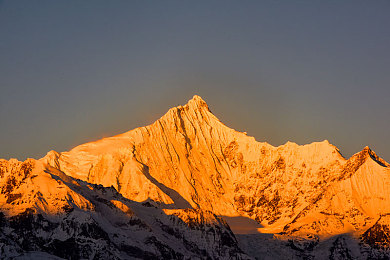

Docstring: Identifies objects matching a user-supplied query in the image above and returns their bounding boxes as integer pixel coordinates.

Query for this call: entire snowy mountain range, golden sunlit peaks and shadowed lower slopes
[0,96,390,259]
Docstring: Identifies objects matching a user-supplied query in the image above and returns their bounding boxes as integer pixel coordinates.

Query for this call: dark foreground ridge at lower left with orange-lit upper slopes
[0,159,249,259]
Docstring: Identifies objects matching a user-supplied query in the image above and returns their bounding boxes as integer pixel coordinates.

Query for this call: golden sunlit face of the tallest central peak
[43,96,345,221]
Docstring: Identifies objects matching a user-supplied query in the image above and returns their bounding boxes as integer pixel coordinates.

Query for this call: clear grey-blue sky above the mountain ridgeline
[0,0,390,161]
